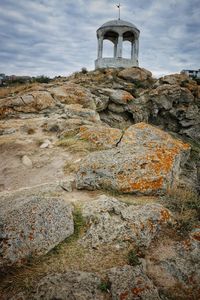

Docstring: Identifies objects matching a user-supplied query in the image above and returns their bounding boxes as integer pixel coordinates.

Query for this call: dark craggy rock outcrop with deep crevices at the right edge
[147,84,200,140]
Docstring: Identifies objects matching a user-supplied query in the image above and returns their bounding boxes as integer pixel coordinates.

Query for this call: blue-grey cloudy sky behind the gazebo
[0,0,200,77]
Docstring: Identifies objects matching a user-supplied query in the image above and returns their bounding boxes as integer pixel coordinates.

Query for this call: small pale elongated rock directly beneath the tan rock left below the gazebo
[64,104,100,122]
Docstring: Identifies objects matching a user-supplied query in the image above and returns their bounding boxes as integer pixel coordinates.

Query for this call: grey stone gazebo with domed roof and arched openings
[95,20,140,69]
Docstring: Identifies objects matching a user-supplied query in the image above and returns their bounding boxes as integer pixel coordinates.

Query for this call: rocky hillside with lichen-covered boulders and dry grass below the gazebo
[0,68,200,300]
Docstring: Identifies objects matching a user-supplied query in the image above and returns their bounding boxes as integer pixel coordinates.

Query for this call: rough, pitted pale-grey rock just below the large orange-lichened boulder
[82,195,171,248]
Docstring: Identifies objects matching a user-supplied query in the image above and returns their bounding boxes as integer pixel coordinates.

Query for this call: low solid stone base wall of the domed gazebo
[95,57,139,69]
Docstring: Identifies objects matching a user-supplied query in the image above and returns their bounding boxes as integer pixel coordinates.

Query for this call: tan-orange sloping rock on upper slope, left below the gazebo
[49,83,96,109]
